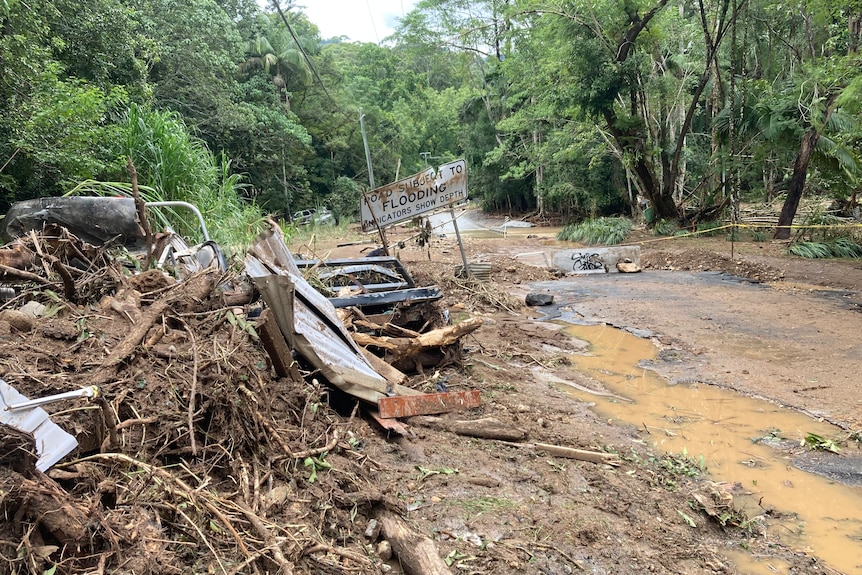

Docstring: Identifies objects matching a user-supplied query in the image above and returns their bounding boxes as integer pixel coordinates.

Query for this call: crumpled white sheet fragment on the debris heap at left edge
[0,379,78,472]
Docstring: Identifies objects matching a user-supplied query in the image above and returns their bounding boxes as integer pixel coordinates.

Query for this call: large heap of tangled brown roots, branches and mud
[0,223,480,574]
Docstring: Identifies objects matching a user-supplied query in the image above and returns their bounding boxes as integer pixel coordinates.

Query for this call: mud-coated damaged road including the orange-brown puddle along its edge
[533,272,862,573]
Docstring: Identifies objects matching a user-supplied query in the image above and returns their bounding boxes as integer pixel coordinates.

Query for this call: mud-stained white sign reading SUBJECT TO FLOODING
[359,160,467,232]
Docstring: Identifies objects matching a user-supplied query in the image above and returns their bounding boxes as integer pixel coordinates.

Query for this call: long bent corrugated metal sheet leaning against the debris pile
[245,224,389,403]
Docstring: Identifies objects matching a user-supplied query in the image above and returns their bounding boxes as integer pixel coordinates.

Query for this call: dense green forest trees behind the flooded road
[0,0,862,245]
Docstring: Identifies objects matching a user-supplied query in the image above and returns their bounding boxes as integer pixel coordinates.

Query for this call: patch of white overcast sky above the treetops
[296,0,417,44]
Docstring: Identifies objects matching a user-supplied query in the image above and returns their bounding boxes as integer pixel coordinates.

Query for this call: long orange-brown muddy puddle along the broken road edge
[560,325,862,574]
